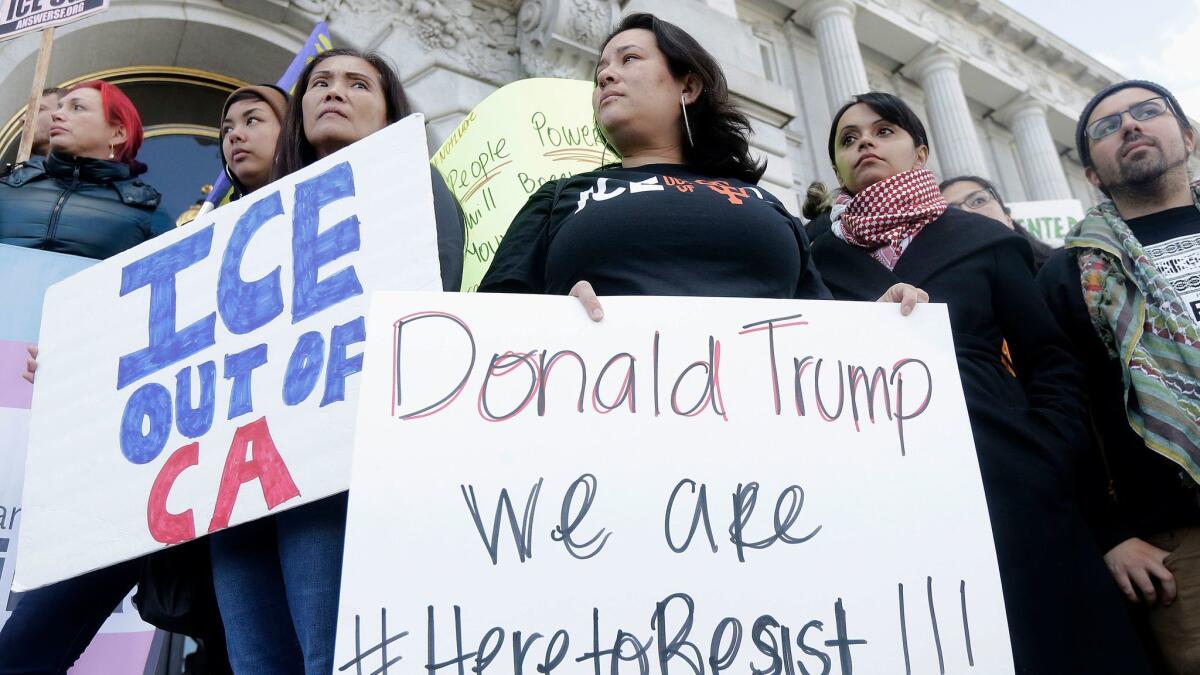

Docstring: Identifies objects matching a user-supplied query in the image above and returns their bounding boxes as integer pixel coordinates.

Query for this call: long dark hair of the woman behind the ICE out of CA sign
[271,48,413,180]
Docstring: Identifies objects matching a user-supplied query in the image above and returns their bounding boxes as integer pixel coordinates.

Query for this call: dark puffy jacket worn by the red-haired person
[0,154,174,259]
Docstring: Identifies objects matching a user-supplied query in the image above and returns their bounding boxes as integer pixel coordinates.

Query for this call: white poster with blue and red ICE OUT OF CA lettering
[14,115,442,587]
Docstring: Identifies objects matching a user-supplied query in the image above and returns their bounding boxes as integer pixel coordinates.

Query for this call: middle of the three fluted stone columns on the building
[905,47,988,178]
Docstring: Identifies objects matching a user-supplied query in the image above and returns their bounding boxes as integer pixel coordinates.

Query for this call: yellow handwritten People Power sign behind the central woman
[433,78,604,291]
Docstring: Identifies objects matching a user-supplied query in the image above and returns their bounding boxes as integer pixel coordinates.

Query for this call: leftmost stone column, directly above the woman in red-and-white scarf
[804,0,870,113]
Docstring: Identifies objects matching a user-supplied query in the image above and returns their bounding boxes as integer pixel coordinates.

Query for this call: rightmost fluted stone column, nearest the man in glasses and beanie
[996,94,1072,199]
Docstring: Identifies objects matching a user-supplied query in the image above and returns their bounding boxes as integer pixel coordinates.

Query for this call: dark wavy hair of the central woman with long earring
[600,12,767,183]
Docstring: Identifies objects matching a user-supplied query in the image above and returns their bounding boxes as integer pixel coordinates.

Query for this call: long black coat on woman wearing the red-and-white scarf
[812,209,1150,675]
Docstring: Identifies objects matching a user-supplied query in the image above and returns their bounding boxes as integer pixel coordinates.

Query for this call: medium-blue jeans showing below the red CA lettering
[210,492,347,675]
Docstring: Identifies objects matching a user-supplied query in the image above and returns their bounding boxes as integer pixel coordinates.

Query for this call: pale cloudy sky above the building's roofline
[1002,0,1200,119]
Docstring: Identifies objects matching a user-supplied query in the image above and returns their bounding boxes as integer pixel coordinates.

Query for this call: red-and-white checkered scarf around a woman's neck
[830,168,946,269]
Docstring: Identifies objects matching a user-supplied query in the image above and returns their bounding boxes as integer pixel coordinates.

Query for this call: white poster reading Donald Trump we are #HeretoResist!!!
[335,293,1013,675]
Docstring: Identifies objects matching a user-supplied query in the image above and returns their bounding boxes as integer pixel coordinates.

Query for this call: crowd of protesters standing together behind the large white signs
[0,5,1200,675]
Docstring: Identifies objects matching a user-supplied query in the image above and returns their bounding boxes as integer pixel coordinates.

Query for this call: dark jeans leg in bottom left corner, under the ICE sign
[0,558,142,675]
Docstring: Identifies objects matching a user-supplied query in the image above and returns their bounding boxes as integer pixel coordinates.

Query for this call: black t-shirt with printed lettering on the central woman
[479,165,832,299]
